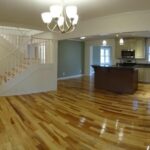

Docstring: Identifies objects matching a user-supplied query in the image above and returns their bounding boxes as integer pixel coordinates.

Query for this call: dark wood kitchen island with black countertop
[92,65,138,94]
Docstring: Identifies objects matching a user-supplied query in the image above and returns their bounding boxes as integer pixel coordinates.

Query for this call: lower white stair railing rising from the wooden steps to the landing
[0,40,51,84]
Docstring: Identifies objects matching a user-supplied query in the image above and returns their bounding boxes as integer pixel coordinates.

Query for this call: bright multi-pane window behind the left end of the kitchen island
[100,46,111,66]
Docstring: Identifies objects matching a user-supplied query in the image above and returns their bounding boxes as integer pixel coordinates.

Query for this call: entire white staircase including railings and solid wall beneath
[0,27,58,96]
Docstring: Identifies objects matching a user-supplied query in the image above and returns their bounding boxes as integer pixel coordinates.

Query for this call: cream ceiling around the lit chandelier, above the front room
[0,0,150,30]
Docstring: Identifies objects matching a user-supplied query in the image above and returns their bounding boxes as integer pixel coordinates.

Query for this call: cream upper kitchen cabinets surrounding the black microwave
[116,38,145,59]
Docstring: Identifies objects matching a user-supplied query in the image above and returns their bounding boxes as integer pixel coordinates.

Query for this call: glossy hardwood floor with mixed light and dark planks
[0,77,150,150]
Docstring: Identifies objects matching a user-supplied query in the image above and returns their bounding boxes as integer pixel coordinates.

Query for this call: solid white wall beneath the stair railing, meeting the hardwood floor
[0,64,57,96]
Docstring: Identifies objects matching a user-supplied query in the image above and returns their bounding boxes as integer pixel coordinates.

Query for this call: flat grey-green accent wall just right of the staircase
[58,40,84,78]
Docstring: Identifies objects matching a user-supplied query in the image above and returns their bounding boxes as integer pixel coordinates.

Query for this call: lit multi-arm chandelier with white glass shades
[41,5,79,33]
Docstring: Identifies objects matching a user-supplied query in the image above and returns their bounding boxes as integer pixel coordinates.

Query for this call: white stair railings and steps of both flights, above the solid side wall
[0,27,52,84]
